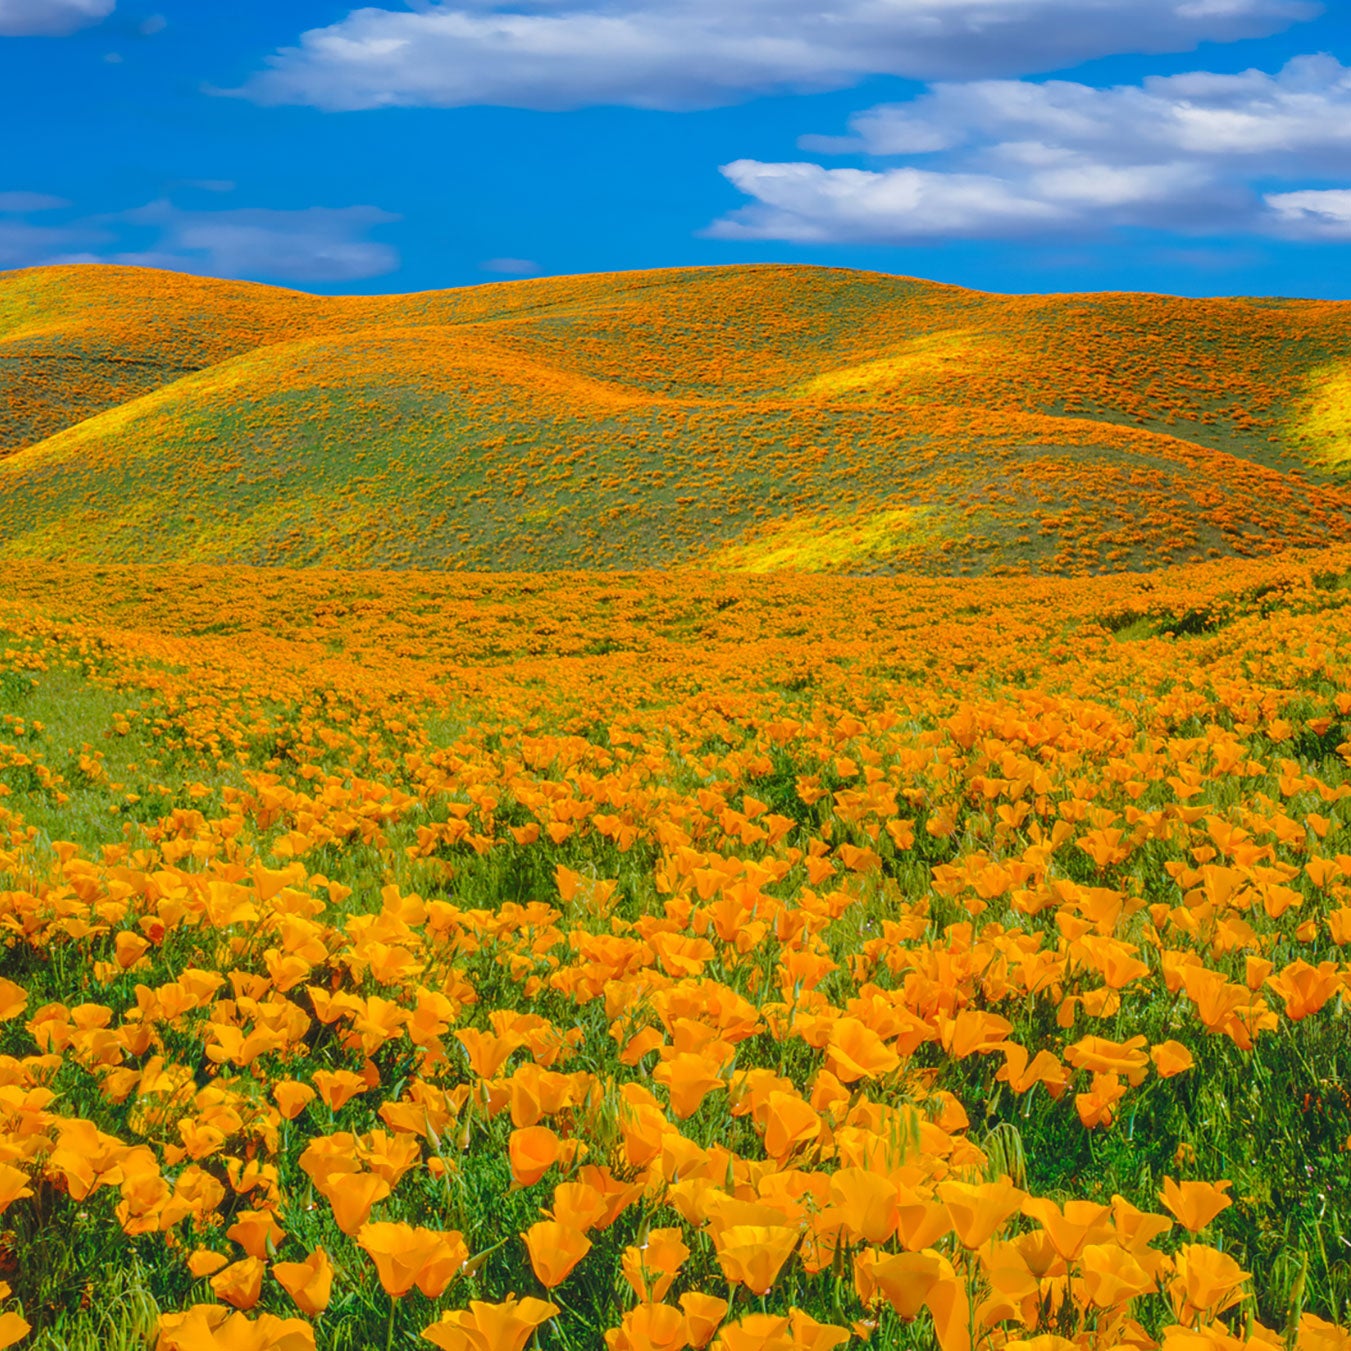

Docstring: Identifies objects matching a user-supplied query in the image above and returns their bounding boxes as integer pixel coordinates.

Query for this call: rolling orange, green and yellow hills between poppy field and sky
[0,266,1351,573]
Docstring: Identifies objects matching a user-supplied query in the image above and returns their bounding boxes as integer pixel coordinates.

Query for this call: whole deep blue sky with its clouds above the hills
[0,0,1351,297]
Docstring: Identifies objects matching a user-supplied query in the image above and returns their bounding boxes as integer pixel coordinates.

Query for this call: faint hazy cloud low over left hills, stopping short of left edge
[107,201,399,281]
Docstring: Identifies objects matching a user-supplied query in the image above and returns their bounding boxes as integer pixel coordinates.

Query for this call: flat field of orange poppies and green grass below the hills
[0,551,1351,1351]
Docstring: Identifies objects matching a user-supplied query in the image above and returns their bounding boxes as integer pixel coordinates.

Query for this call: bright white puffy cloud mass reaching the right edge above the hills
[708,55,1351,243]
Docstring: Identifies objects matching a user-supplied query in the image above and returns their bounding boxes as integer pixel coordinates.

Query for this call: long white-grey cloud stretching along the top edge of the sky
[226,0,1320,109]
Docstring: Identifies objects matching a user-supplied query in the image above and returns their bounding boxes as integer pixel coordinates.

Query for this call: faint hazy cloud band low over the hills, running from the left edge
[0,192,400,282]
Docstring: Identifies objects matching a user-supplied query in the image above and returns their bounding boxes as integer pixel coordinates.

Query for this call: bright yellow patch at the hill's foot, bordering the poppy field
[698,507,943,573]
